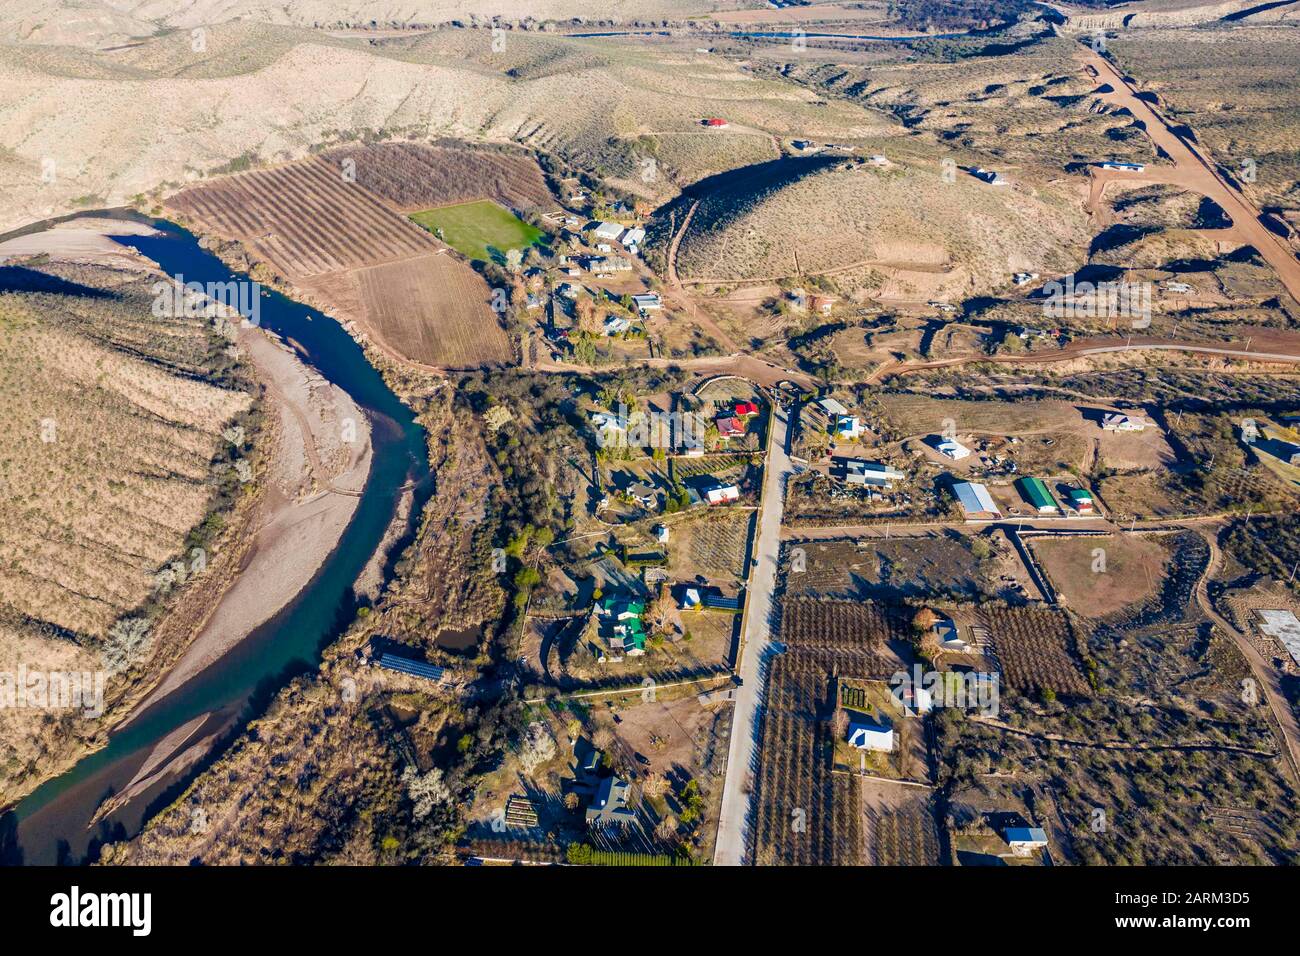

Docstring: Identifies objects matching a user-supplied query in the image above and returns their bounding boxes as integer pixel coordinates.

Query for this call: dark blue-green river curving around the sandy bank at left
[0,211,432,865]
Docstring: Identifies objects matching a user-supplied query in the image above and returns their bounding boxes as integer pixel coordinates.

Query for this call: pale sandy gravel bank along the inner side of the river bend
[0,217,372,796]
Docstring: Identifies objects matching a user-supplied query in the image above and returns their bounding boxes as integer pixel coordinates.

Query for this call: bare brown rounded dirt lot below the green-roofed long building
[1030,535,1169,618]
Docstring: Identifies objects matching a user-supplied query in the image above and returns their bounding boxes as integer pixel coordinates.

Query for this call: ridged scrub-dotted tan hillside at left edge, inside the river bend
[0,261,257,803]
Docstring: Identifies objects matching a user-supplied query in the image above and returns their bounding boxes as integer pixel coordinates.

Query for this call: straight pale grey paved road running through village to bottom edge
[714,408,794,866]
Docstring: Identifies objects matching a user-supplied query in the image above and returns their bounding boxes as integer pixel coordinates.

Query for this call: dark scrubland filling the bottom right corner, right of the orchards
[936,522,1296,865]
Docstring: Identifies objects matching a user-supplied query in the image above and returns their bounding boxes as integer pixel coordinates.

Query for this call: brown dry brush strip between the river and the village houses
[104,393,519,864]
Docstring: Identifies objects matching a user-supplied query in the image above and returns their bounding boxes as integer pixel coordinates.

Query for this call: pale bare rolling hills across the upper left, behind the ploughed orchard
[0,22,896,230]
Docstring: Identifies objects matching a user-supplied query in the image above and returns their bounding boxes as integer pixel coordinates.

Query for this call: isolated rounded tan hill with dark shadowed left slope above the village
[655,160,1087,295]
